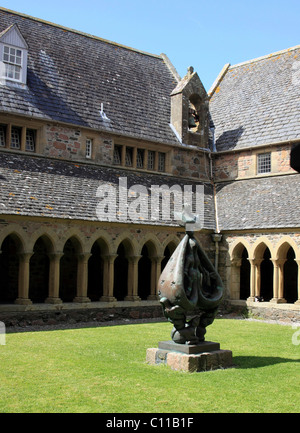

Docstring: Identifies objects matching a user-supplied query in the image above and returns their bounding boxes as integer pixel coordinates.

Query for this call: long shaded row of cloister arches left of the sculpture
[0,224,179,305]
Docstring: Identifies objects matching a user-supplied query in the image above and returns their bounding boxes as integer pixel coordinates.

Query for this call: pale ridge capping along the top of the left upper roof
[0,6,163,60]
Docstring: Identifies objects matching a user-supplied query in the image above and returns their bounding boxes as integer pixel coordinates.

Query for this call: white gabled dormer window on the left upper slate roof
[0,25,28,84]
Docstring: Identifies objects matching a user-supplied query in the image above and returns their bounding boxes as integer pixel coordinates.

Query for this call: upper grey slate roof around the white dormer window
[0,8,178,144]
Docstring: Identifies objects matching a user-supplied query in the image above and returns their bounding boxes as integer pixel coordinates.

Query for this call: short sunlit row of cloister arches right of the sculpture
[229,236,300,304]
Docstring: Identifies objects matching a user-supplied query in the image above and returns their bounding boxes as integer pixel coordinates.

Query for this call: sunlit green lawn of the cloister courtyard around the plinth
[0,319,300,413]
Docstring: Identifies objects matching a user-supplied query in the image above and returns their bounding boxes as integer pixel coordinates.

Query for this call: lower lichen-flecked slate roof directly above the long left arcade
[0,152,215,229]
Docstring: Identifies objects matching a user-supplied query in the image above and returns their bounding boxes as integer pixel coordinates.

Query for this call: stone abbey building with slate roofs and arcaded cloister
[0,8,300,324]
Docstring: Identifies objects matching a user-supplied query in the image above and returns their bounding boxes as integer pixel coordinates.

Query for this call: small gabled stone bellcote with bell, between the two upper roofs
[171,66,209,148]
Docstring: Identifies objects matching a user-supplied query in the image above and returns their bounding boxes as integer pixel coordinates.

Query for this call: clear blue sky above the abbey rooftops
[0,0,300,91]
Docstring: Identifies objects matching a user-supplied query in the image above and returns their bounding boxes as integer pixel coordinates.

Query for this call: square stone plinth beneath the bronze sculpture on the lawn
[146,341,233,373]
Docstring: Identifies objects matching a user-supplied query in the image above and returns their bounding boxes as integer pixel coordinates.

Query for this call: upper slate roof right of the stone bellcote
[209,46,300,151]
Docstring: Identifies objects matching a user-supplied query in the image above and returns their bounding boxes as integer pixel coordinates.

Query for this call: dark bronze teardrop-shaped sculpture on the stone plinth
[158,214,224,345]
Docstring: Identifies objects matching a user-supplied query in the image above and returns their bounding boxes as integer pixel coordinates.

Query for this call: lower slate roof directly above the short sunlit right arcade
[217,174,300,230]
